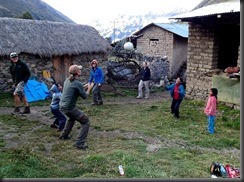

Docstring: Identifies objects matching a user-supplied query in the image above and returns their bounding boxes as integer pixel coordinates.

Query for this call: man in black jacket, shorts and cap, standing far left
[9,52,31,114]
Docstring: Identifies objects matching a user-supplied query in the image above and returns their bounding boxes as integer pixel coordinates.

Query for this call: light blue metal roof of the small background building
[154,23,188,38]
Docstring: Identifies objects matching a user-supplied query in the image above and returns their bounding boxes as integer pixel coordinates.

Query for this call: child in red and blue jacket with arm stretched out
[166,77,185,119]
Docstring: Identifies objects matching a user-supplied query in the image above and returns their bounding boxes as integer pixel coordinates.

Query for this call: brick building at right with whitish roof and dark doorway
[172,0,240,107]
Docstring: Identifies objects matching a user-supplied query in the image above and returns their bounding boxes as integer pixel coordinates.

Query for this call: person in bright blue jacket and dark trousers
[88,59,104,105]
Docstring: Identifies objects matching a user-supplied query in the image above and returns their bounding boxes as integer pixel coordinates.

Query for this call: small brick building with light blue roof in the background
[131,23,188,78]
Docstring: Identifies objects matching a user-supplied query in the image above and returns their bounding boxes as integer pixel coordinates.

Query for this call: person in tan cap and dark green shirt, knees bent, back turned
[59,65,90,150]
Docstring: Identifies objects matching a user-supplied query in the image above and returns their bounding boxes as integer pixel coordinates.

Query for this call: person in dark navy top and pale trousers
[136,61,151,99]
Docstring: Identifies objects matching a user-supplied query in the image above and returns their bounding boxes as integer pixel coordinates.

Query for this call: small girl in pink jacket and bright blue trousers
[204,88,218,134]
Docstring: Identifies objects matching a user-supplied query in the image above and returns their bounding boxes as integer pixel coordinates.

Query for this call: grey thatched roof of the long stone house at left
[0,18,111,57]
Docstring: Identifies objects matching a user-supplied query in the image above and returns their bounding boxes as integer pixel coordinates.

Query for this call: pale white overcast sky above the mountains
[42,0,202,24]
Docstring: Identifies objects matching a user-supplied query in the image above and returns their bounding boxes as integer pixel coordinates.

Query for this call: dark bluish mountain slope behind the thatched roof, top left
[0,0,74,23]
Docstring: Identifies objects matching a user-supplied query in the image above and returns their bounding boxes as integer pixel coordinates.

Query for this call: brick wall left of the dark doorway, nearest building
[186,23,218,100]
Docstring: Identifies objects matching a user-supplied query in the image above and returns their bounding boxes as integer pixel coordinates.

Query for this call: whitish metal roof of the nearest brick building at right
[170,2,241,19]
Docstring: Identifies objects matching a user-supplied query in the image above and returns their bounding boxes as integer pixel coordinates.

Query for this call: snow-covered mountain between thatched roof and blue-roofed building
[91,9,187,42]
